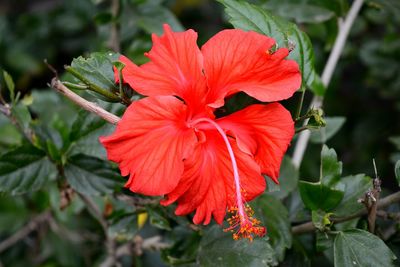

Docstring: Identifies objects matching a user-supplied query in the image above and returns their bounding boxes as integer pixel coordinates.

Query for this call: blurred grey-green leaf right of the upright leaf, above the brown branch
[333,174,372,216]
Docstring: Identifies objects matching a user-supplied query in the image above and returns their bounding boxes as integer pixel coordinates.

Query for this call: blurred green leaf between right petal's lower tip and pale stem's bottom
[267,156,299,199]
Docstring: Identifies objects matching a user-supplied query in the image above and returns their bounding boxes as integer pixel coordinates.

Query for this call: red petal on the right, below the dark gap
[217,103,294,183]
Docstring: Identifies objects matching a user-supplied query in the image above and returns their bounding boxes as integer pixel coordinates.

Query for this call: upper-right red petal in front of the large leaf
[201,29,301,107]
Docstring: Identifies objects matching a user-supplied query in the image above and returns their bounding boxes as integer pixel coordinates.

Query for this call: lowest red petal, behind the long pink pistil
[161,130,266,224]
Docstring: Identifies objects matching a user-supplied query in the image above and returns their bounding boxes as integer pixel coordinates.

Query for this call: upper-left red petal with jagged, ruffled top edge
[115,25,207,114]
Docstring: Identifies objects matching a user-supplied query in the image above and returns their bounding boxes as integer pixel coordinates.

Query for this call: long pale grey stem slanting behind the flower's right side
[292,0,364,168]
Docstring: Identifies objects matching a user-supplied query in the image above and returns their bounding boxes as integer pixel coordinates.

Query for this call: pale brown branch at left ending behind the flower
[51,78,120,124]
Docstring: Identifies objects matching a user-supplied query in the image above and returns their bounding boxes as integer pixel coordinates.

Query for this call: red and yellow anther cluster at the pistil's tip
[224,205,266,241]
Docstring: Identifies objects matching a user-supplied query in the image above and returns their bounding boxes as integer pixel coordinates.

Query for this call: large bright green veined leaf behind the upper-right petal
[218,0,315,89]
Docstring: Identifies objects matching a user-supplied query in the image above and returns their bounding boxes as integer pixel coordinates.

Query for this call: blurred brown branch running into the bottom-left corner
[0,211,51,253]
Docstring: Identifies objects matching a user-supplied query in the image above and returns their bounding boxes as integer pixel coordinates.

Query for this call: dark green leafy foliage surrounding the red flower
[0,0,400,267]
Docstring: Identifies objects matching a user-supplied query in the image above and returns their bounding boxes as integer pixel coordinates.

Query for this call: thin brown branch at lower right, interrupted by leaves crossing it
[292,192,400,235]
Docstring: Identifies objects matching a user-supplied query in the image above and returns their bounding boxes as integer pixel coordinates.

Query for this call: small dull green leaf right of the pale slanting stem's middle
[310,117,346,144]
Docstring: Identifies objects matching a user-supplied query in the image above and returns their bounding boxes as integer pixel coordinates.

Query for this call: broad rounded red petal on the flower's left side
[100,96,197,195]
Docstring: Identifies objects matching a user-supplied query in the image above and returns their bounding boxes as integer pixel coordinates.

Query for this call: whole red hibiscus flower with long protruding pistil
[100,25,301,239]
